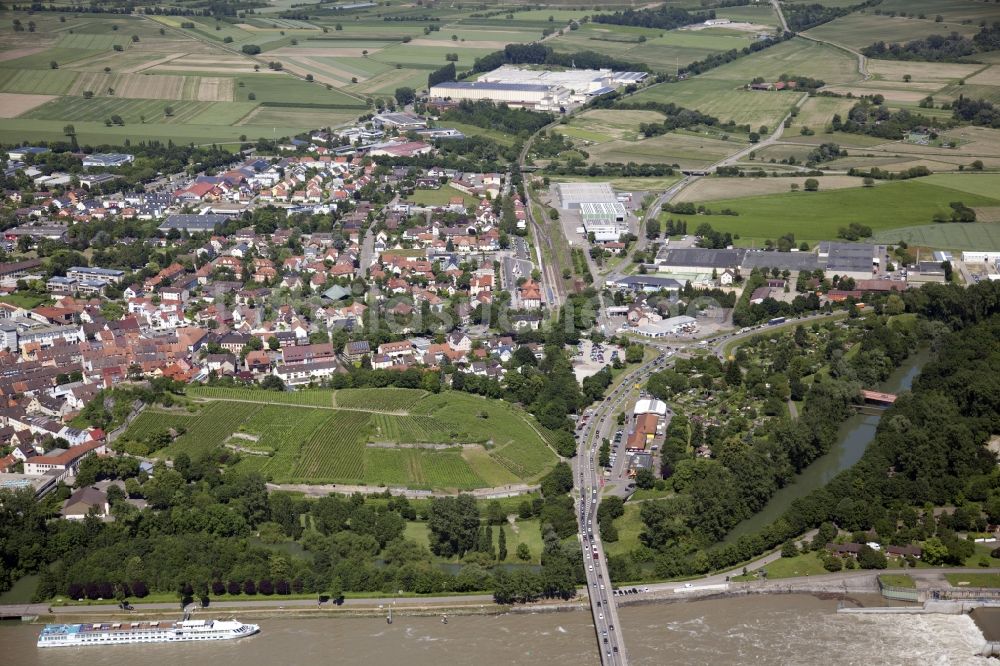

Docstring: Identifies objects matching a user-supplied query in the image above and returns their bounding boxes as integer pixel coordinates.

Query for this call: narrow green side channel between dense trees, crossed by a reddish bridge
[725,348,932,543]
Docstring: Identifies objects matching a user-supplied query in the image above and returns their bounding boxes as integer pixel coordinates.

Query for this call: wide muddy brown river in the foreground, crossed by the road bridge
[0,595,988,666]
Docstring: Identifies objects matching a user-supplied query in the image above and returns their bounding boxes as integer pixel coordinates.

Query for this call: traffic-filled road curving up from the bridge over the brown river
[573,353,667,666]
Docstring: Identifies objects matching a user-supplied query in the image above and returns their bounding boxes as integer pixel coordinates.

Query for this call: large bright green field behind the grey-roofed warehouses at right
[664,178,1000,245]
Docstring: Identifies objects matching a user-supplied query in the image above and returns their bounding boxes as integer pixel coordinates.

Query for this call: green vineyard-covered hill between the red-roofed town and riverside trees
[123,387,556,490]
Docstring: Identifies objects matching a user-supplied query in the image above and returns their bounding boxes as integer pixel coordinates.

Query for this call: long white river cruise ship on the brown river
[38,620,260,647]
